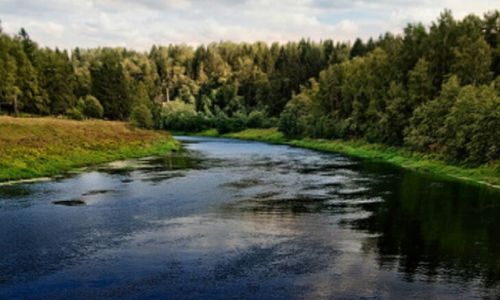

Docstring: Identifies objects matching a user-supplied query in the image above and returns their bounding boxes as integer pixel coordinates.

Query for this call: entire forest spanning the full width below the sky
[0,10,500,165]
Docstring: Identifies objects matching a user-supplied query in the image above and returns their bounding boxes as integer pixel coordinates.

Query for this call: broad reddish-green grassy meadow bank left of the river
[0,116,178,181]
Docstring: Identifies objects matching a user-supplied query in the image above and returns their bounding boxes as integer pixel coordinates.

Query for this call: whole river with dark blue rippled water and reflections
[0,138,500,299]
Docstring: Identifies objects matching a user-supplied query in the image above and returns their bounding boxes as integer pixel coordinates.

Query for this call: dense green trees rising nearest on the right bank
[279,11,500,164]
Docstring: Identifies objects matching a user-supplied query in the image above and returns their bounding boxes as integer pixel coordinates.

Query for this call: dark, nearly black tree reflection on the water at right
[348,172,500,287]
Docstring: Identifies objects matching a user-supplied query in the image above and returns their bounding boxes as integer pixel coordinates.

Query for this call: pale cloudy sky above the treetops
[0,0,500,51]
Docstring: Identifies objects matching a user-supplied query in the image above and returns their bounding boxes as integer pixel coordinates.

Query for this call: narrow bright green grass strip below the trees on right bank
[196,128,500,188]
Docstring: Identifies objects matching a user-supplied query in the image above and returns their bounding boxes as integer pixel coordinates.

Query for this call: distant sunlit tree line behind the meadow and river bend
[0,22,338,120]
